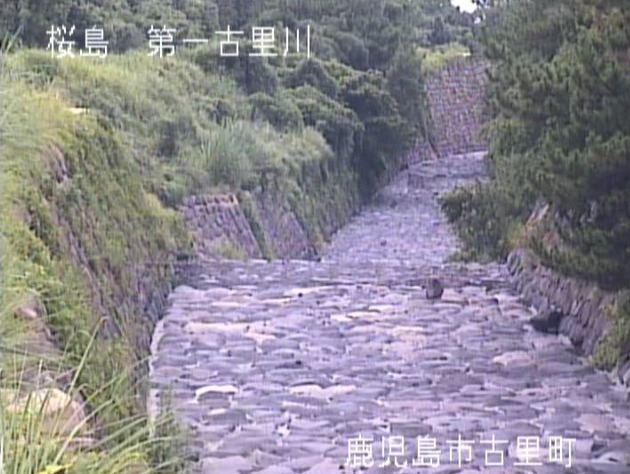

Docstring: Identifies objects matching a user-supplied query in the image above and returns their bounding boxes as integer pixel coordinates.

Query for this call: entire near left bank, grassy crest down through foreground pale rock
[0,82,198,474]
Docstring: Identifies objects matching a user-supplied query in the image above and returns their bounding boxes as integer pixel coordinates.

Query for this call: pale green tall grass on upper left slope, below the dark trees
[7,50,249,206]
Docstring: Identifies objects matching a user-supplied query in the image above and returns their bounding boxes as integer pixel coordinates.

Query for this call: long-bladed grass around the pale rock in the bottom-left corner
[0,330,188,474]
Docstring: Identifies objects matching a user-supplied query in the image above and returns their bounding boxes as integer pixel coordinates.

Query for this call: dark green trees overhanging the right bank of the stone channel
[443,0,630,366]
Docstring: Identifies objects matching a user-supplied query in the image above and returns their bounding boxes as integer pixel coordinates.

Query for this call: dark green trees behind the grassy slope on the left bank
[0,0,484,197]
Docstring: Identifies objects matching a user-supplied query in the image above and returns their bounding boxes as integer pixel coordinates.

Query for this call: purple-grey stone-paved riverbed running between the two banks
[151,155,630,474]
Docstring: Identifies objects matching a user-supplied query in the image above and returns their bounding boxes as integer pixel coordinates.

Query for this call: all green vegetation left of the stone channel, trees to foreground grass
[0,0,476,468]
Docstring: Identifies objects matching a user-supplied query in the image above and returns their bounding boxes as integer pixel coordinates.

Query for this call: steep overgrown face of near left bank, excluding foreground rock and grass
[2,87,190,412]
